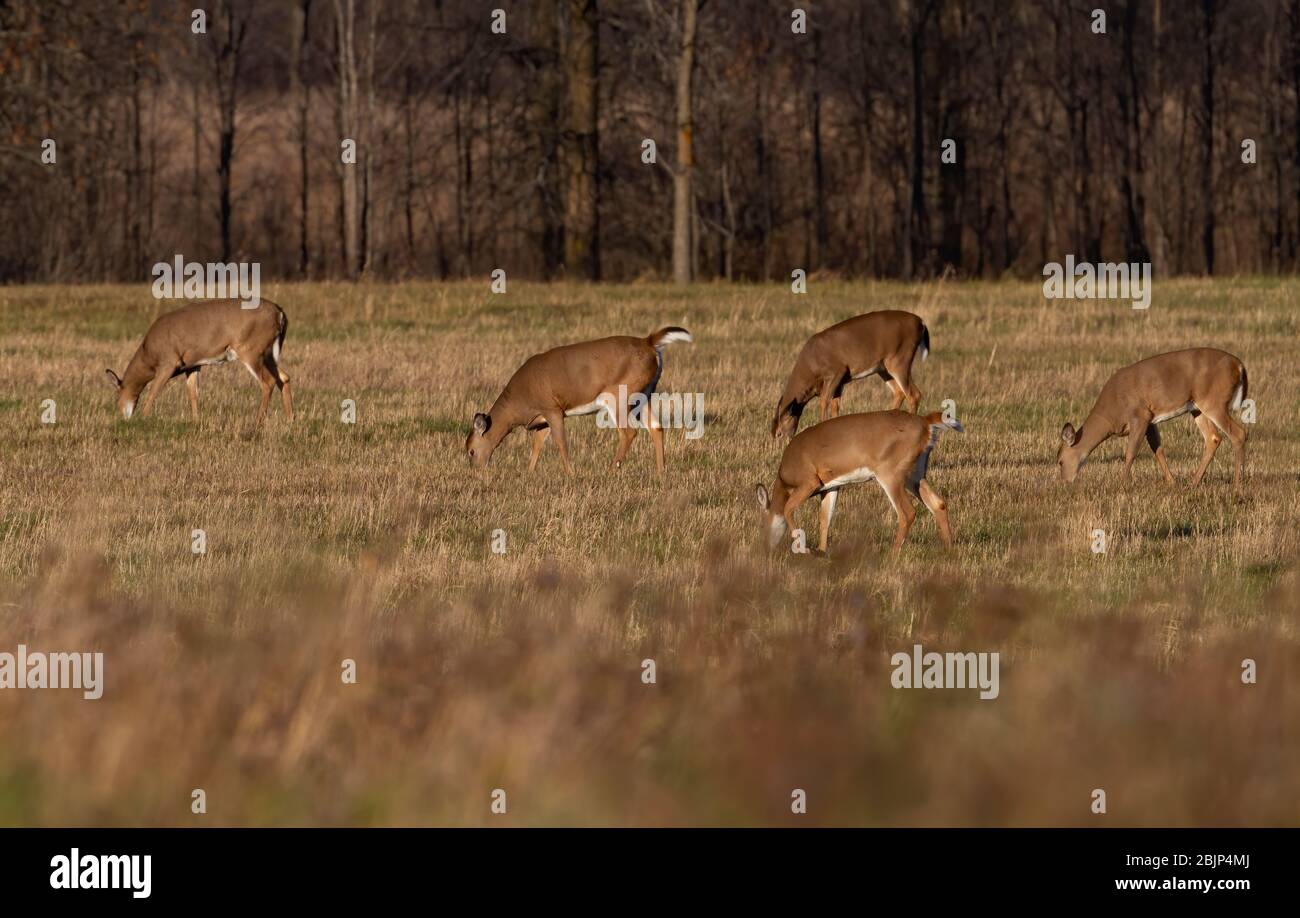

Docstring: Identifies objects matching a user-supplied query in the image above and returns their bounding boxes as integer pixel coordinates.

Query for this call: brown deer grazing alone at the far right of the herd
[1057,347,1249,490]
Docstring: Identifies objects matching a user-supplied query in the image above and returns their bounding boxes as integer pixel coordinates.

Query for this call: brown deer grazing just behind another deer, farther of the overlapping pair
[772,309,930,439]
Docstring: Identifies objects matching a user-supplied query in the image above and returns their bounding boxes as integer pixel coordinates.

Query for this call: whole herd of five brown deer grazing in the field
[108,299,1248,551]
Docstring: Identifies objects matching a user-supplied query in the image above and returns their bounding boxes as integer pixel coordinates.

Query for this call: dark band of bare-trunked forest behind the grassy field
[0,0,1300,281]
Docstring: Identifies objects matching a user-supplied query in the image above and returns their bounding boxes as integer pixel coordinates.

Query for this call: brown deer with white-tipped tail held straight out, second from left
[465,325,692,475]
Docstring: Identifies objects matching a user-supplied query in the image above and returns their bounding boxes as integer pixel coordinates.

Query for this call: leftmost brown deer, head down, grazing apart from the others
[108,299,294,424]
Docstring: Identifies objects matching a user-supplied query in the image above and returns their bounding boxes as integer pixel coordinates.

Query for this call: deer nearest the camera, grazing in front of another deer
[758,408,963,553]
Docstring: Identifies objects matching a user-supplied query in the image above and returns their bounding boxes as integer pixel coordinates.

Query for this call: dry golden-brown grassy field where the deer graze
[0,280,1300,826]
